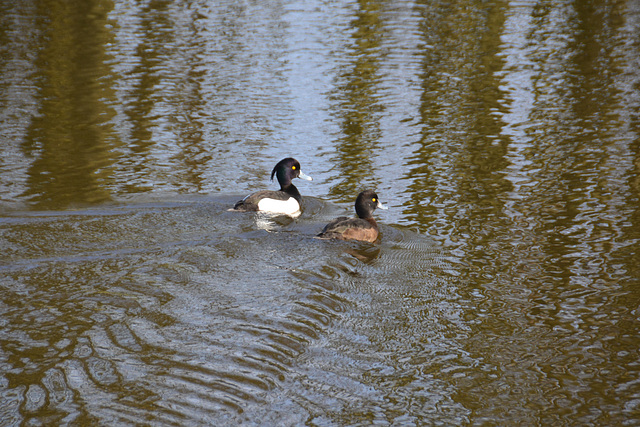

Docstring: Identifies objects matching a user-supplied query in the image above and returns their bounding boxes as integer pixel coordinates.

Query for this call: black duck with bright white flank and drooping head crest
[231,157,313,217]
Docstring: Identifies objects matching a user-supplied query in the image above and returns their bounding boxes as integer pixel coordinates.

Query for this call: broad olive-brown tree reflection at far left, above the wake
[22,1,117,209]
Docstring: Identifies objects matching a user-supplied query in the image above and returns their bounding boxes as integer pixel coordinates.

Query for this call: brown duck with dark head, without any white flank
[316,190,388,242]
